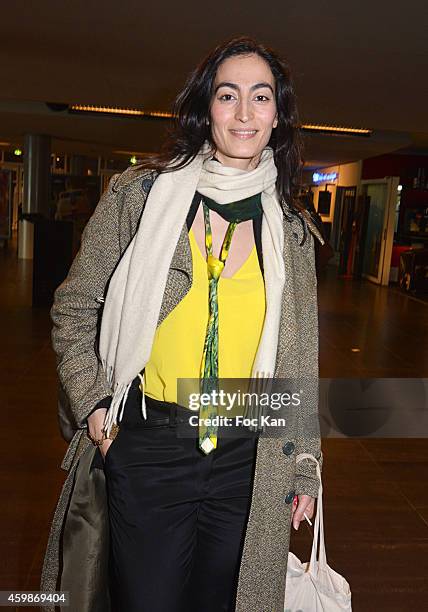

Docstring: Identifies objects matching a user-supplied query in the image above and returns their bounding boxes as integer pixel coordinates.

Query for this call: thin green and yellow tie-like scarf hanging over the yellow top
[199,193,263,454]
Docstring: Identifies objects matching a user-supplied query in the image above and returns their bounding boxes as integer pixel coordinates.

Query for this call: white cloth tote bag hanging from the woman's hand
[284,453,352,612]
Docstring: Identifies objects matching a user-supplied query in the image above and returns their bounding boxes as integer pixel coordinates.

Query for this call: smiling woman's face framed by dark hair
[211,53,278,170]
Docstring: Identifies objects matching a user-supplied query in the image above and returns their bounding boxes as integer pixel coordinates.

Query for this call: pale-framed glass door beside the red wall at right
[360,176,400,285]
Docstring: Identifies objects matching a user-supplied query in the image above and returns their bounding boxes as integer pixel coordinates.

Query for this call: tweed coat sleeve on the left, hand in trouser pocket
[50,175,121,428]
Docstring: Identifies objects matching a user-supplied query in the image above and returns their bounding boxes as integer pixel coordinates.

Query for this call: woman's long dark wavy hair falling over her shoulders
[136,36,304,212]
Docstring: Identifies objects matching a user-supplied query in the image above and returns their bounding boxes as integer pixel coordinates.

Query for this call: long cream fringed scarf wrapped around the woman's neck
[99,142,284,434]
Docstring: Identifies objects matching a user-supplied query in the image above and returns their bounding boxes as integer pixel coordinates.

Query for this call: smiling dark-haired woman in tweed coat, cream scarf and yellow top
[42,38,322,612]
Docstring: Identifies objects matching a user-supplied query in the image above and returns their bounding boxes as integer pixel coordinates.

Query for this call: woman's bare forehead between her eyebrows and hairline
[214,53,275,87]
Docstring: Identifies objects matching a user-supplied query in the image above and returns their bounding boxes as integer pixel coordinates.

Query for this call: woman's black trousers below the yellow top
[104,378,257,612]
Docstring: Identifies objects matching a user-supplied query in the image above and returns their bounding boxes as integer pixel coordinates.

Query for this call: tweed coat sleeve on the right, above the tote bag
[295,225,323,497]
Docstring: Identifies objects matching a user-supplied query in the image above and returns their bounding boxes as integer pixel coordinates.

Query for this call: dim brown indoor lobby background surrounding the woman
[0,0,428,612]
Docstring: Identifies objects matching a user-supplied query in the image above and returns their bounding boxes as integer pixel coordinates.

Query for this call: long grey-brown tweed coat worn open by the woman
[41,168,323,612]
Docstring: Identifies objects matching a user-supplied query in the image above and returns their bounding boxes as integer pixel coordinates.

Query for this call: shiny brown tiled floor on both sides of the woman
[0,233,428,612]
